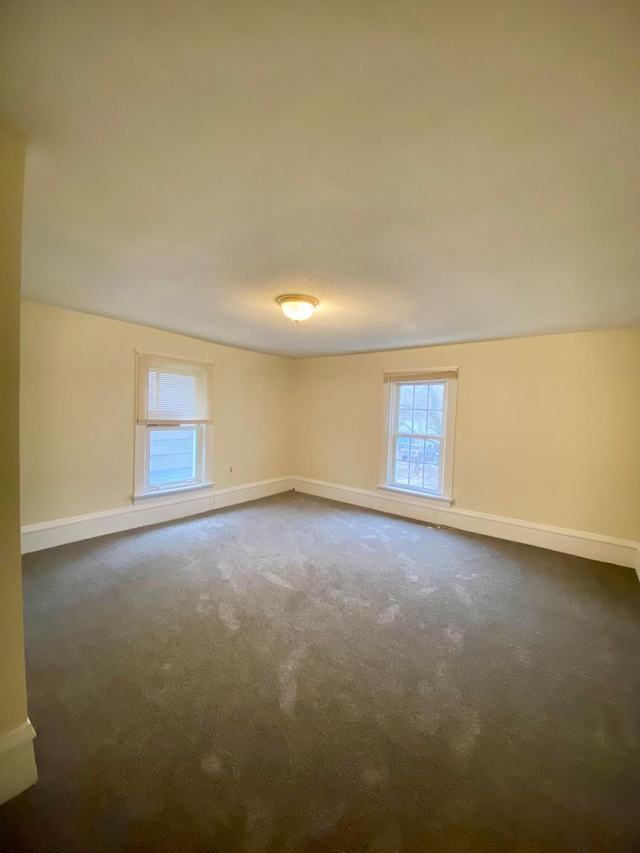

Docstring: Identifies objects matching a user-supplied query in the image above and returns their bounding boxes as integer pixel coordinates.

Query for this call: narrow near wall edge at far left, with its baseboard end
[0,120,35,802]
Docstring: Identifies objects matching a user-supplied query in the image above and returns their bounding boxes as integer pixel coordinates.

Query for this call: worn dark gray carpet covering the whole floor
[0,492,640,853]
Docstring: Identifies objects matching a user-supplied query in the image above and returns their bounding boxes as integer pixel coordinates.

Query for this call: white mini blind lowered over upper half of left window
[137,352,212,425]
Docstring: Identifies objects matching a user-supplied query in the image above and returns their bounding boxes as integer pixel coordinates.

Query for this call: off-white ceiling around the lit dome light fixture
[0,0,640,355]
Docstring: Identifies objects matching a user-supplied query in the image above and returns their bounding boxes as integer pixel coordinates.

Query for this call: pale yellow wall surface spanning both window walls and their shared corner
[21,303,640,540]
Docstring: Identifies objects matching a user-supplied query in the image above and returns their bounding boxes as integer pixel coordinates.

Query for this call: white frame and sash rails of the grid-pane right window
[379,370,458,505]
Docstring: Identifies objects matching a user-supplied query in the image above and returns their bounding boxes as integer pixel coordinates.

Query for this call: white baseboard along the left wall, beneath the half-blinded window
[21,477,293,554]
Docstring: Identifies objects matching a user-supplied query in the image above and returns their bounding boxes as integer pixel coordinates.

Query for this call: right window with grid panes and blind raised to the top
[384,368,458,500]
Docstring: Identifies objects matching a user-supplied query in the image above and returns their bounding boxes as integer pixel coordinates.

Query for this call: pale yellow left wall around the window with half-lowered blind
[21,302,294,524]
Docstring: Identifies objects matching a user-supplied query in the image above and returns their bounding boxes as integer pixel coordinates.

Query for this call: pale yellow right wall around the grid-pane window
[295,329,640,540]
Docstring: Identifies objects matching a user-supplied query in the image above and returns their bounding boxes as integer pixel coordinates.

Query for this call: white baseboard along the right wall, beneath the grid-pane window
[292,477,640,578]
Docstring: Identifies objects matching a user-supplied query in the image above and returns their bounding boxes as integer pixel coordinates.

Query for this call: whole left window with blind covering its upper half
[135,353,212,497]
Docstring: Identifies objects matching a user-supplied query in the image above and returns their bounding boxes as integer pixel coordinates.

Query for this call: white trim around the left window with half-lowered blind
[132,350,215,504]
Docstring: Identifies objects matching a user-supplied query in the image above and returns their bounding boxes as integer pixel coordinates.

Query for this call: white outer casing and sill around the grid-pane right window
[378,368,458,506]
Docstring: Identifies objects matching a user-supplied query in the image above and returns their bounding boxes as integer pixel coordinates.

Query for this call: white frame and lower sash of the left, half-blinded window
[133,351,215,503]
